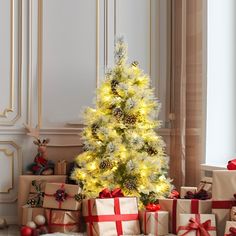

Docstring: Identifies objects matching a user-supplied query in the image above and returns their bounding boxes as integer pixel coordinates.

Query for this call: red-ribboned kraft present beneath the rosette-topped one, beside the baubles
[45,209,84,233]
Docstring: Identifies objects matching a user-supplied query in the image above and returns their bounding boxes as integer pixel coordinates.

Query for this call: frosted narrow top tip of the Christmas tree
[115,37,127,65]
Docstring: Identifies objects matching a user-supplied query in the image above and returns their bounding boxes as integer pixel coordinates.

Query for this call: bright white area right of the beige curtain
[206,0,236,165]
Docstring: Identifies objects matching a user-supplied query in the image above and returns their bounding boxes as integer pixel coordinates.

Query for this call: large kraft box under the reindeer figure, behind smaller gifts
[17,175,67,225]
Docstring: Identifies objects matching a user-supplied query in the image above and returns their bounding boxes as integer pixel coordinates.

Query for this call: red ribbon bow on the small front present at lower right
[178,214,216,236]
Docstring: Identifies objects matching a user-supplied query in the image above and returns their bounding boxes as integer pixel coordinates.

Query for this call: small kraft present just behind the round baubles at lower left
[21,205,44,225]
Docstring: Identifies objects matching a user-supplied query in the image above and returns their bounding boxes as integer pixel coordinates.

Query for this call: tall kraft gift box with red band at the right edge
[212,170,236,235]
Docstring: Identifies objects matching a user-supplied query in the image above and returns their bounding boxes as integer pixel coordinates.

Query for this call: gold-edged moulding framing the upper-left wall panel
[0,0,22,126]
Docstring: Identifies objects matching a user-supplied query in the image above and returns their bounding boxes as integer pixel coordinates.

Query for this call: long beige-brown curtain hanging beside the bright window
[170,0,205,187]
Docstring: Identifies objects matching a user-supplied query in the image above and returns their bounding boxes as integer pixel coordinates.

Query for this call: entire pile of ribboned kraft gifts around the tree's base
[18,164,236,236]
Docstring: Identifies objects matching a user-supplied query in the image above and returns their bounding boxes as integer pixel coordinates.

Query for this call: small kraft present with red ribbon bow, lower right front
[178,214,216,236]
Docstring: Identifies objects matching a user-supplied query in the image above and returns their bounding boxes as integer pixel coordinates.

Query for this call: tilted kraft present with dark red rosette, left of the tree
[43,183,83,210]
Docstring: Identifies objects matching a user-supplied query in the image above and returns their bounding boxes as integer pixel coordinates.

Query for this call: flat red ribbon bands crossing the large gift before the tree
[85,198,139,236]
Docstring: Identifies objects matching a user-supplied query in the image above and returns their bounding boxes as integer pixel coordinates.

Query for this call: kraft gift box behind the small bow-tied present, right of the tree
[159,199,212,234]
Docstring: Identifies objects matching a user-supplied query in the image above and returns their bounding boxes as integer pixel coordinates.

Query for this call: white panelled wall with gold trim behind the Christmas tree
[0,0,169,223]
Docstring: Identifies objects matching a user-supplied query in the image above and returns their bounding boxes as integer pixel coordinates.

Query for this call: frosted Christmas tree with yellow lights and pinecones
[71,38,172,204]
